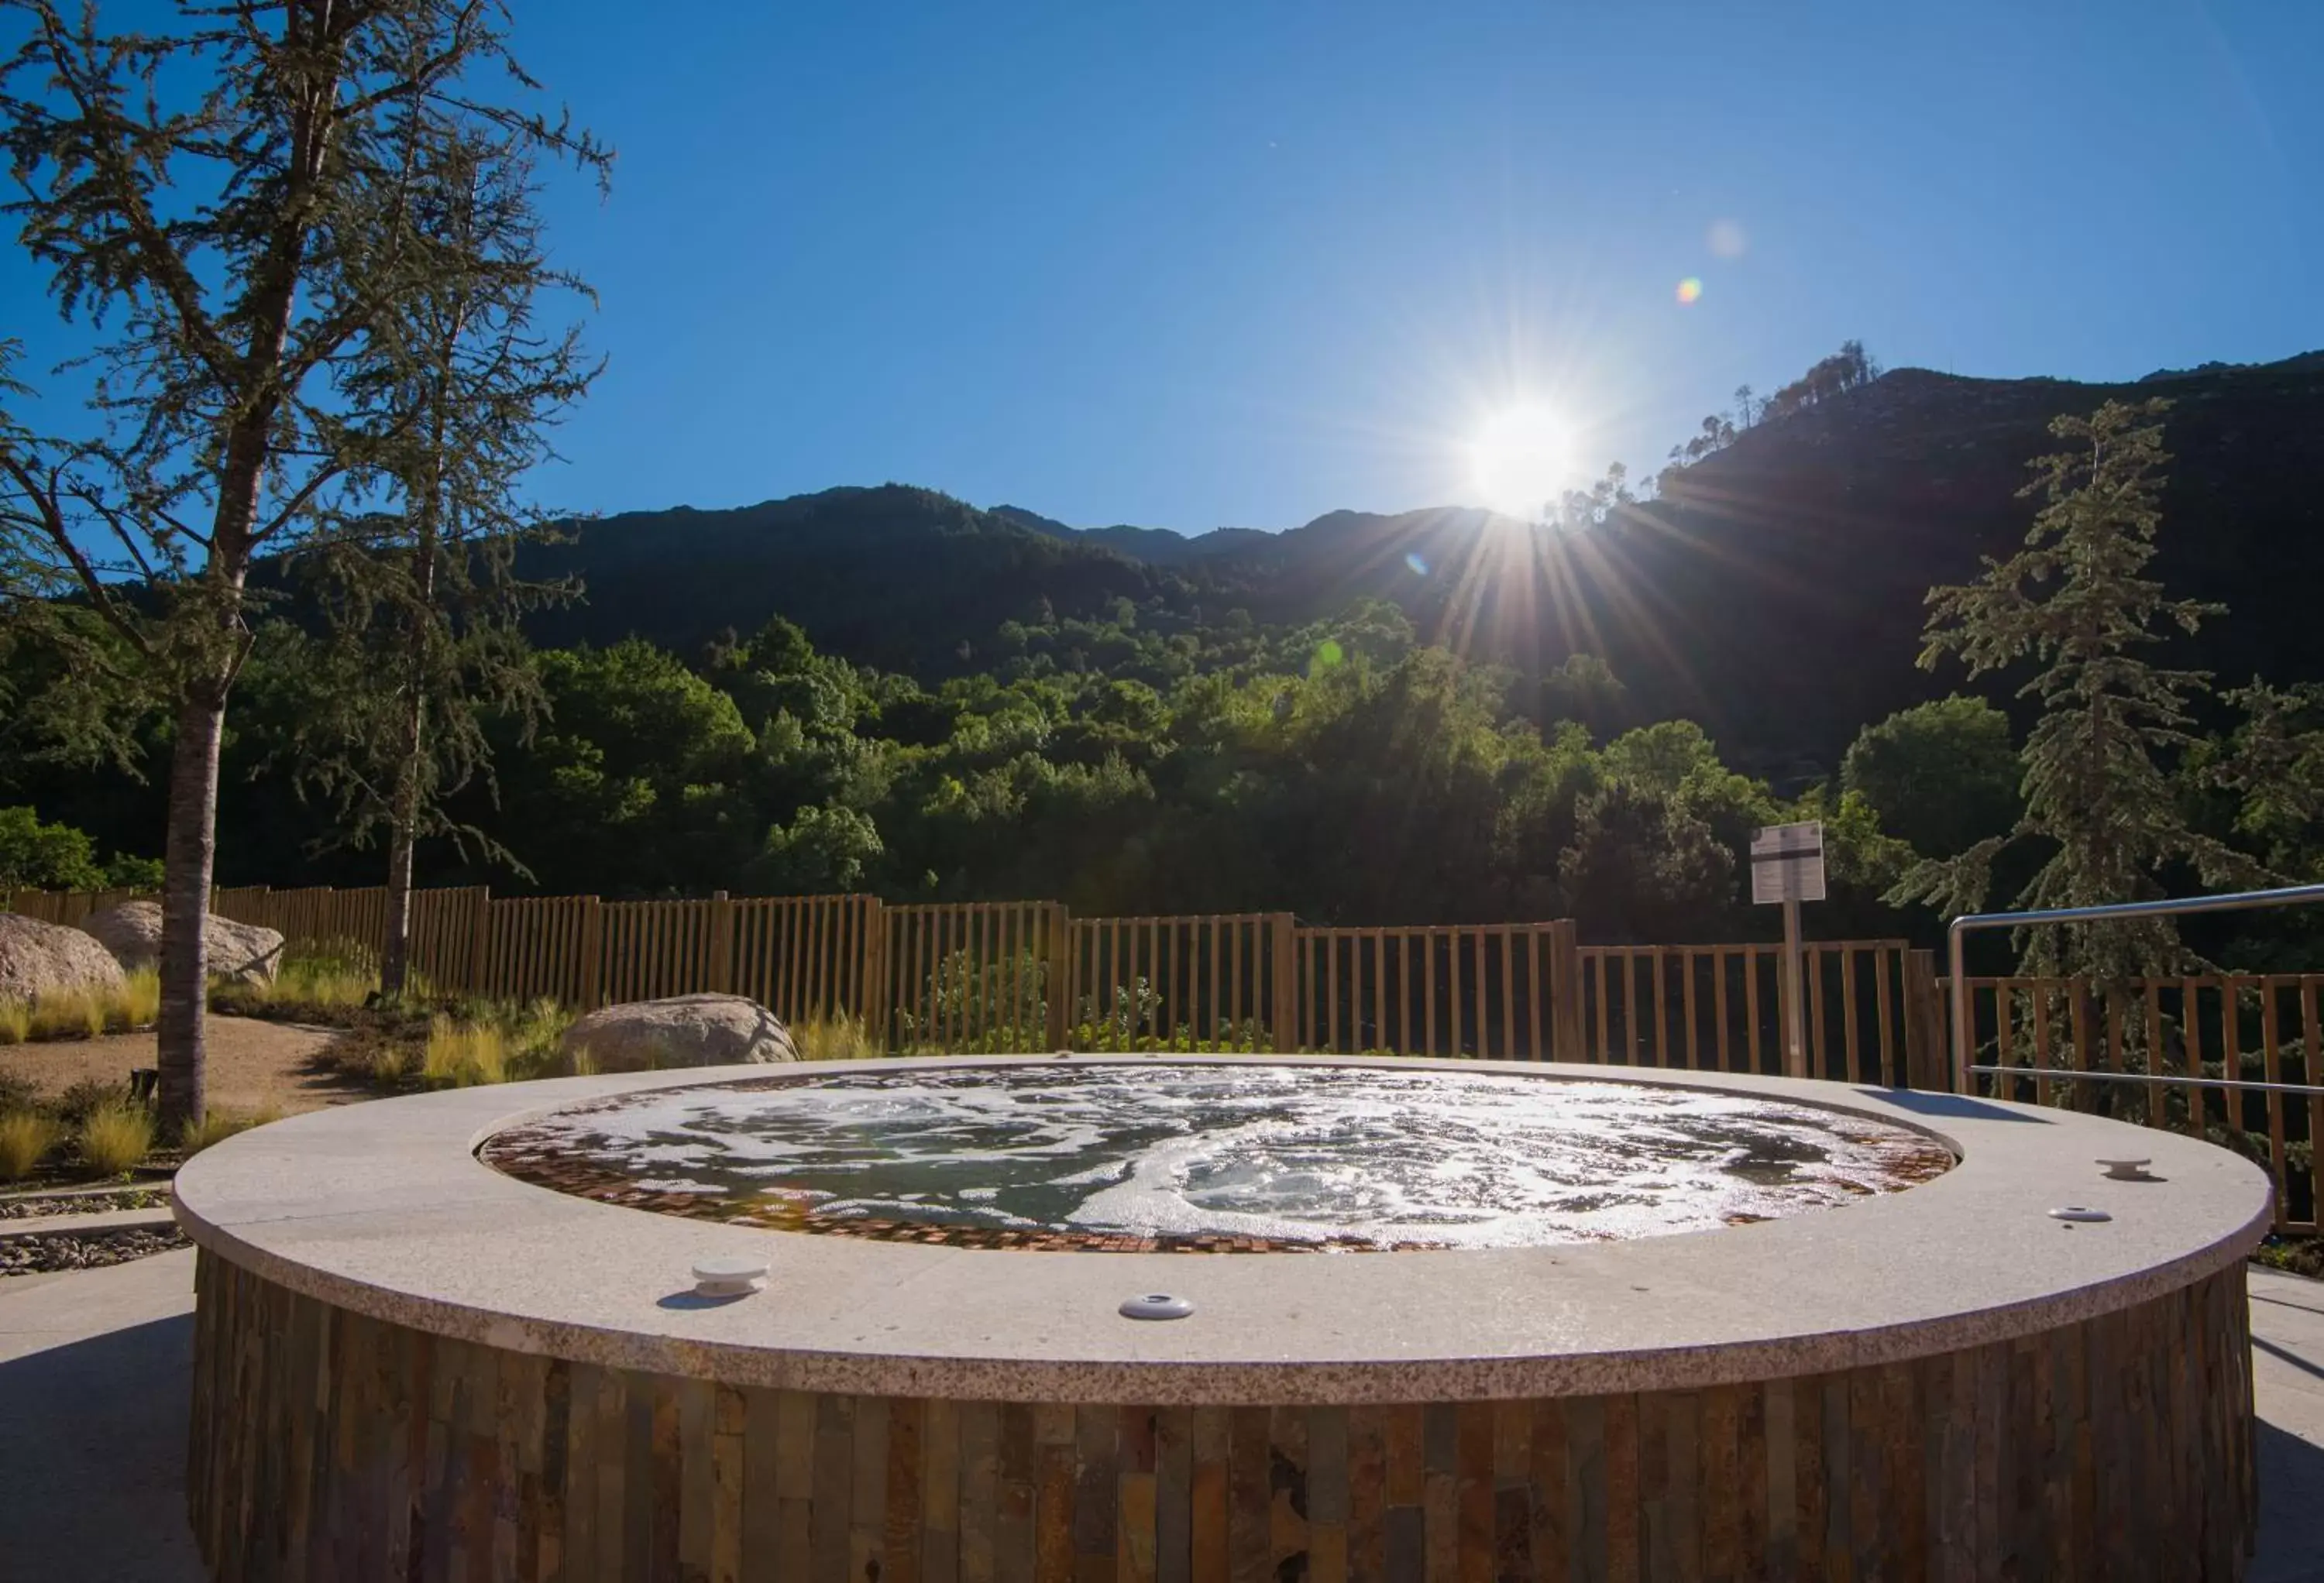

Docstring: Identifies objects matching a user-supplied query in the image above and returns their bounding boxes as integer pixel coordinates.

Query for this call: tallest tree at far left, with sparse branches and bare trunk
[0,0,609,1128]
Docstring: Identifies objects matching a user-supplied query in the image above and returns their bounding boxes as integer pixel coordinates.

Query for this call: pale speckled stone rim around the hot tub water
[177,1058,2268,1406]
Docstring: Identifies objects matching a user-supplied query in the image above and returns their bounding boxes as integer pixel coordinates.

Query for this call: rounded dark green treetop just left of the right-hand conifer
[1841,692,2024,858]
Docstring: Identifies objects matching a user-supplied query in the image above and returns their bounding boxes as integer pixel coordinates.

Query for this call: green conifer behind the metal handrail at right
[1889,400,2252,981]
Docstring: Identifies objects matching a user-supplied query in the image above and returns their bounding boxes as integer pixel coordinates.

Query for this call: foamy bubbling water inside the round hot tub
[486,1060,1952,1248]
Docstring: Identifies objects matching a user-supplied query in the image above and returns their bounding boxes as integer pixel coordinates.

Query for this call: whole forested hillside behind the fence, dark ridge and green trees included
[0,360,2324,957]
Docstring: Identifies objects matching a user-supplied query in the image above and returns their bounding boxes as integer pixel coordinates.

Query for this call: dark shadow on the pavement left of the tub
[0,1313,202,1583]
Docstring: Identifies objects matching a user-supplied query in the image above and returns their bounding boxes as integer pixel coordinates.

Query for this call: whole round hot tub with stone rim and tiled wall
[177,1058,2268,1583]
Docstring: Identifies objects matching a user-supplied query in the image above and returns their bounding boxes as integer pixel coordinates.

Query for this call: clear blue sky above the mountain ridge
[0,0,2324,530]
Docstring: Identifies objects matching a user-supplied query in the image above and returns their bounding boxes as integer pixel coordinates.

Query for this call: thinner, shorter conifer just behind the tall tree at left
[286,132,597,995]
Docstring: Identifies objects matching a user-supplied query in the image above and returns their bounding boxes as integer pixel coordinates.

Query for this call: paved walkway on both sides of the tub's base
[0,1251,2324,1583]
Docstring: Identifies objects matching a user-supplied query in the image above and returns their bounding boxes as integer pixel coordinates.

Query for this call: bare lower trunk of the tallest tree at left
[156,685,225,1137]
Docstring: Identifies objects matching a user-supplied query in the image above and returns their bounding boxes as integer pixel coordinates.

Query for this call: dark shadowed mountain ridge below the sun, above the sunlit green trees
[509,353,2324,769]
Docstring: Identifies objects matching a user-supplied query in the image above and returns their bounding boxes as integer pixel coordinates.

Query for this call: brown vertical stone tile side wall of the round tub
[191,1253,2254,1583]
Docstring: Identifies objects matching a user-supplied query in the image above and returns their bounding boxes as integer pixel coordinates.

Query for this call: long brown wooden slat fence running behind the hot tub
[7,886,2324,1230]
